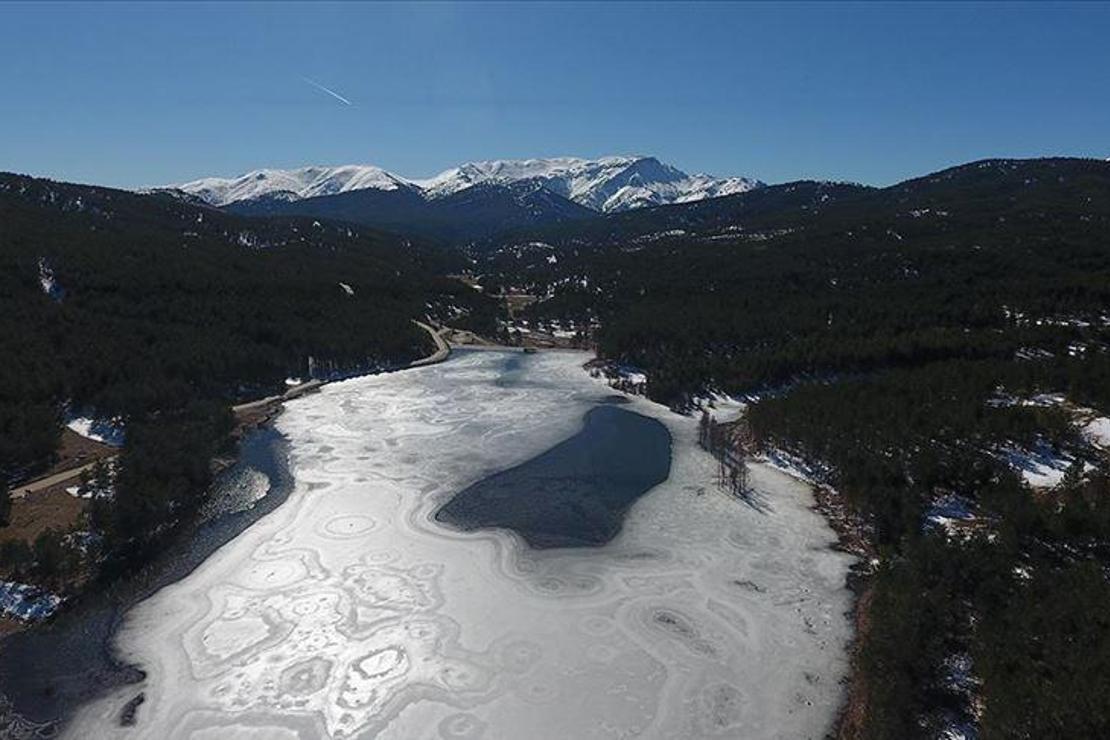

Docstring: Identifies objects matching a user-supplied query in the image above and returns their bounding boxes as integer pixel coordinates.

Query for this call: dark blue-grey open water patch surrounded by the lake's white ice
[435,405,670,548]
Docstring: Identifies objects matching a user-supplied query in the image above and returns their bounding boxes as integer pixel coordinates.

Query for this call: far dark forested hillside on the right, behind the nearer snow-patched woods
[481,160,1110,399]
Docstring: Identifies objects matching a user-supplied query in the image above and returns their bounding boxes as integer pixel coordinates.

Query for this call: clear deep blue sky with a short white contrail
[0,3,1110,186]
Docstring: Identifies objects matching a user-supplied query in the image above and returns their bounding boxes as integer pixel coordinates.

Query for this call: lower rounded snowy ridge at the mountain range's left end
[171,164,413,206]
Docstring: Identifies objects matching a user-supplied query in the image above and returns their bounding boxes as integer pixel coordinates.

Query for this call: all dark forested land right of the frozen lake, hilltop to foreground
[478,159,1110,738]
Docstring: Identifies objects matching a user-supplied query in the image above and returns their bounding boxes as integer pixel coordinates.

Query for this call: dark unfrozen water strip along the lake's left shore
[0,426,293,738]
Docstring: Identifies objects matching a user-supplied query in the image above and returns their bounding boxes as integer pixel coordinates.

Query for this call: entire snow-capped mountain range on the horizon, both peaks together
[172,156,763,213]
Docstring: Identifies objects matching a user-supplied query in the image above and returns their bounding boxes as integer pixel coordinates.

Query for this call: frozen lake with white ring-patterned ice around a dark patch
[68,352,851,740]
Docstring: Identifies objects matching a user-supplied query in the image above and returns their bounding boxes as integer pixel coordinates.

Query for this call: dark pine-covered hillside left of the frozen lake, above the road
[0,174,481,483]
